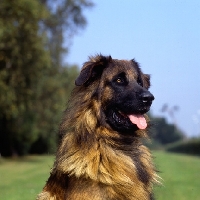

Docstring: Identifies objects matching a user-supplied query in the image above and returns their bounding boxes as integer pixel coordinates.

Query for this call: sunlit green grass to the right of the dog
[154,151,200,200]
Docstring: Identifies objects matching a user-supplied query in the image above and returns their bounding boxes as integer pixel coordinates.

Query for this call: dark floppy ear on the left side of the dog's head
[75,55,112,86]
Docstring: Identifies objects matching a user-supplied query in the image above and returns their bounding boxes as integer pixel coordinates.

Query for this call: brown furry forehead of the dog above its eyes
[104,59,138,78]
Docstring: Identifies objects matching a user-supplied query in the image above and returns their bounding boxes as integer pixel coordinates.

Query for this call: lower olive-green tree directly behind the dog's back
[30,66,78,154]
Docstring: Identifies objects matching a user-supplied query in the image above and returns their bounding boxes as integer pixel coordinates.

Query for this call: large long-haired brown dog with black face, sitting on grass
[37,54,159,200]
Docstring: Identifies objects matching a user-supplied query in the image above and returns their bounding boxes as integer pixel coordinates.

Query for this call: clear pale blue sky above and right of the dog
[66,0,200,137]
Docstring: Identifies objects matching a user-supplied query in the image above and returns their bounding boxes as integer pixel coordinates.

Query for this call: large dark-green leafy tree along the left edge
[0,0,50,155]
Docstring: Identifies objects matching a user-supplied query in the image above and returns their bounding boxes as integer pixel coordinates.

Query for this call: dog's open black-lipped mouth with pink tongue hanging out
[112,109,149,130]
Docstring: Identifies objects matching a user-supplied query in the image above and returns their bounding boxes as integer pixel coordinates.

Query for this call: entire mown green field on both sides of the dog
[0,151,200,200]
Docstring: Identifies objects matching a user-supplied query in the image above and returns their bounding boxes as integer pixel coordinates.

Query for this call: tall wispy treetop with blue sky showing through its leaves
[41,0,93,67]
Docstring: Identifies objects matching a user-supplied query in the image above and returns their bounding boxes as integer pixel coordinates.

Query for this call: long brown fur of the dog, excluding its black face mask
[37,55,158,200]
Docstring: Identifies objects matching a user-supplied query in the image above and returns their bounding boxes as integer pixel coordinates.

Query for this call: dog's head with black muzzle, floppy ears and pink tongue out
[75,55,154,133]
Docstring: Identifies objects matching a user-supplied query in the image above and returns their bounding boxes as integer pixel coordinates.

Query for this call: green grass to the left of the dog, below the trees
[0,156,54,200]
